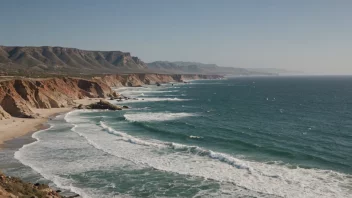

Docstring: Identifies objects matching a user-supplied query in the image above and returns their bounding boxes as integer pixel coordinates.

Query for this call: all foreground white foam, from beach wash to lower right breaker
[16,112,352,198]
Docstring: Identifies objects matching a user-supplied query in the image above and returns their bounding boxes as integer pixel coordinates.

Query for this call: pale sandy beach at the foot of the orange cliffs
[0,98,100,147]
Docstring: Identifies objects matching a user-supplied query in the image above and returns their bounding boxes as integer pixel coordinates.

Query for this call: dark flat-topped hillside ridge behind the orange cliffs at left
[0,46,147,74]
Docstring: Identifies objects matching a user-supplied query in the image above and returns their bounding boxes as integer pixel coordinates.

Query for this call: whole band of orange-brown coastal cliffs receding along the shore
[0,74,221,120]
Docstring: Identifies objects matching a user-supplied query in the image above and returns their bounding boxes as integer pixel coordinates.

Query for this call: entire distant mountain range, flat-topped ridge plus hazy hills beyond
[0,46,298,75]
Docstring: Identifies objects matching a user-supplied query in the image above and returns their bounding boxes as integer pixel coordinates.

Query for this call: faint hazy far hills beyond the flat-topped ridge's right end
[147,61,270,75]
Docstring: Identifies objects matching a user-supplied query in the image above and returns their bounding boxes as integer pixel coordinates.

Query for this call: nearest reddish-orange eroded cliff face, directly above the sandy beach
[0,78,112,118]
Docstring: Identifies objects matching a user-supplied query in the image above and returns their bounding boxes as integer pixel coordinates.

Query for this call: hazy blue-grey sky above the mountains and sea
[0,0,352,74]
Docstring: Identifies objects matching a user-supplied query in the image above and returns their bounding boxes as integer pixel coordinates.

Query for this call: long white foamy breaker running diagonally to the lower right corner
[95,120,352,197]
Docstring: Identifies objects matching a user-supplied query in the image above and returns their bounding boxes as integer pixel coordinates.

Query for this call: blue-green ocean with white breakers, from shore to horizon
[1,76,352,198]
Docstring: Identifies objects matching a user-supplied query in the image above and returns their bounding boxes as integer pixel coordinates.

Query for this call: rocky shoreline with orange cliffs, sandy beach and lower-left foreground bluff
[0,74,220,198]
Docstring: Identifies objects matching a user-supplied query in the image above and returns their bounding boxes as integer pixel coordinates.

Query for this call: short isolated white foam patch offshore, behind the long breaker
[124,113,197,122]
